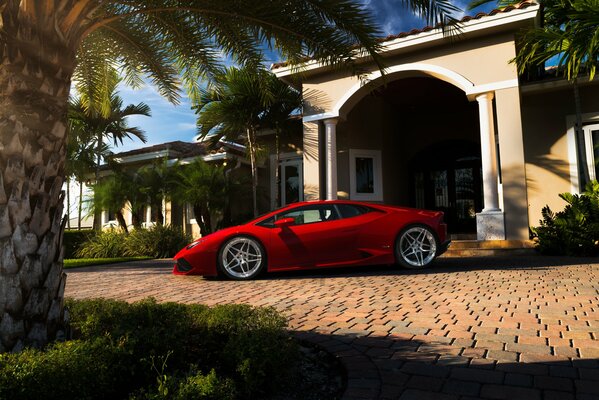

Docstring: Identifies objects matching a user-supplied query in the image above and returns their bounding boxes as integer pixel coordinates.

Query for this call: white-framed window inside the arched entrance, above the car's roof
[349,149,383,201]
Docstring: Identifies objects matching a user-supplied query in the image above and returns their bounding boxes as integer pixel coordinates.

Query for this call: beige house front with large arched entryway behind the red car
[273,3,599,240]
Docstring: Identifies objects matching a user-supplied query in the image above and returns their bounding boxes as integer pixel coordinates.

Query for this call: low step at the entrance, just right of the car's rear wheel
[442,240,536,258]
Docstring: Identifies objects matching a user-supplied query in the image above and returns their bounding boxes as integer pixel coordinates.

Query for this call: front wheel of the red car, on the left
[217,236,266,281]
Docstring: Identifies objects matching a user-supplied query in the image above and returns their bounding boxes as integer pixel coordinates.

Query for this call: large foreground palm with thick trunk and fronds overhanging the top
[0,0,449,352]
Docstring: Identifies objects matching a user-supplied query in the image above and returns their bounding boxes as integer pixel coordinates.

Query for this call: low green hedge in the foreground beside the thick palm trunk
[0,299,299,400]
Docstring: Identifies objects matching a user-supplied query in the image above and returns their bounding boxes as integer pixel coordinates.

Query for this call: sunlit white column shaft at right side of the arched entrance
[476,92,500,213]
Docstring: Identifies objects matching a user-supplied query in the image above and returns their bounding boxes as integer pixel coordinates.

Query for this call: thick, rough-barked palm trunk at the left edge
[0,12,77,352]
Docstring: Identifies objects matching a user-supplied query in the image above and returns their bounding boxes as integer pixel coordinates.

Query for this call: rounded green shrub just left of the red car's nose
[124,225,191,258]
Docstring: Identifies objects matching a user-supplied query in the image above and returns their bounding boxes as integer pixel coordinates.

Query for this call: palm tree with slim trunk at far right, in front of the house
[470,0,599,188]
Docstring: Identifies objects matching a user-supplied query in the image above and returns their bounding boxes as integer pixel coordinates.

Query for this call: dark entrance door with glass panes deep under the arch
[412,142,483,234]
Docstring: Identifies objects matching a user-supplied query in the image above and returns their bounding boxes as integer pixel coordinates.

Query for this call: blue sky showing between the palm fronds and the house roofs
[113,0,493,152]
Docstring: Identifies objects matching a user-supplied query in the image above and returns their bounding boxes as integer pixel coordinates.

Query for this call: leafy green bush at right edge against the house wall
[532,181,599,256]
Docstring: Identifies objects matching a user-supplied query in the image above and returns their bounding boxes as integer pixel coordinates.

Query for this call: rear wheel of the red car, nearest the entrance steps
[395,225,439,269]
